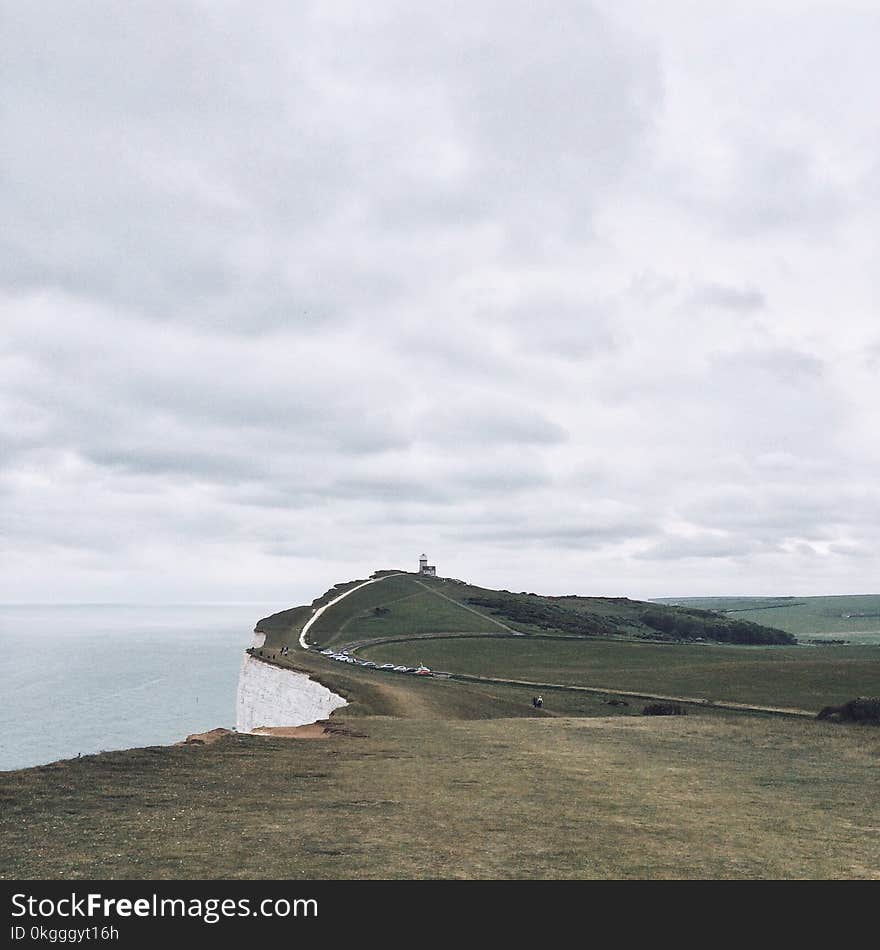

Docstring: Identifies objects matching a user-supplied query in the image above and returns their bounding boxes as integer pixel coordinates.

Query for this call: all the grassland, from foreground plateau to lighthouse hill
[6,575,880,879]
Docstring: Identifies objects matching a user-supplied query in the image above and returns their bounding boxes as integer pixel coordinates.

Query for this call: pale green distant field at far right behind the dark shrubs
[658,594,880,644]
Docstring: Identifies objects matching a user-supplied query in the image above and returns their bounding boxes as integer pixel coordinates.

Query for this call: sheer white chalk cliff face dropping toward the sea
[236,656,347,732]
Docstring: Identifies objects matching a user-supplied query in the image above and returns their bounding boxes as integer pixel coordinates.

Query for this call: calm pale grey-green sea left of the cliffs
[0,604,282,770]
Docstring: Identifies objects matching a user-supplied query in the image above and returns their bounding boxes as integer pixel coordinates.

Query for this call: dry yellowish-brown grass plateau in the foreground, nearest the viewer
[0,717,880,879]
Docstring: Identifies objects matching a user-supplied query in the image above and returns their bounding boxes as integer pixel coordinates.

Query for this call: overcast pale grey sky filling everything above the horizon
[0,0,880,604]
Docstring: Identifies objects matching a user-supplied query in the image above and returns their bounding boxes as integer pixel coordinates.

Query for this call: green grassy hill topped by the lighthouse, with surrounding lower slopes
[249,574,880,719]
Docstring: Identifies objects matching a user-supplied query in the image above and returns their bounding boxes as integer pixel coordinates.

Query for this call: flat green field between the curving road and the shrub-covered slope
[359,638,880,712]
